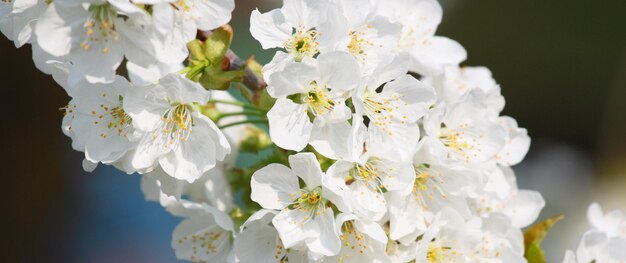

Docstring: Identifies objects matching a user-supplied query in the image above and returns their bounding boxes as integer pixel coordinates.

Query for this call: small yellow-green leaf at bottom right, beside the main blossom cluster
[524,216,563,263]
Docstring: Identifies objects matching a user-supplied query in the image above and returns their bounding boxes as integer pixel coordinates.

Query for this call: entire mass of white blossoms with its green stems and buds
[0,0,623,262]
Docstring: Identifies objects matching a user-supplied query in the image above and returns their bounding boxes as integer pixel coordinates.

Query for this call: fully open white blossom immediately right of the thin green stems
[267,52,360,155]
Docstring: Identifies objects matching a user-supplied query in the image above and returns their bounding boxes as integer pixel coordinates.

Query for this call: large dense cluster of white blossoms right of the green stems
[241,0,544,262]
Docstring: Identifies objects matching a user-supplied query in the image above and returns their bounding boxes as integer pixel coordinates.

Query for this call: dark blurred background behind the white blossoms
[0,0,626,262]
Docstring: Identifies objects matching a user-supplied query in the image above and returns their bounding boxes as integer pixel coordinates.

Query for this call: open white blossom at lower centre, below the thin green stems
[251,153,340,256]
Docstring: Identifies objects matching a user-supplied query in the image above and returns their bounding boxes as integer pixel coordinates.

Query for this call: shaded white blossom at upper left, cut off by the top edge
[35,0,156,82]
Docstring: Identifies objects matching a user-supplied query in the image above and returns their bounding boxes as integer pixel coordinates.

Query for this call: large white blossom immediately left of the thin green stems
[124,74,230,183]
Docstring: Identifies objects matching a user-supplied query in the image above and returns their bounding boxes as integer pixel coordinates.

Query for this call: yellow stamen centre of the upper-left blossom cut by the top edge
[80,3,119,54]
